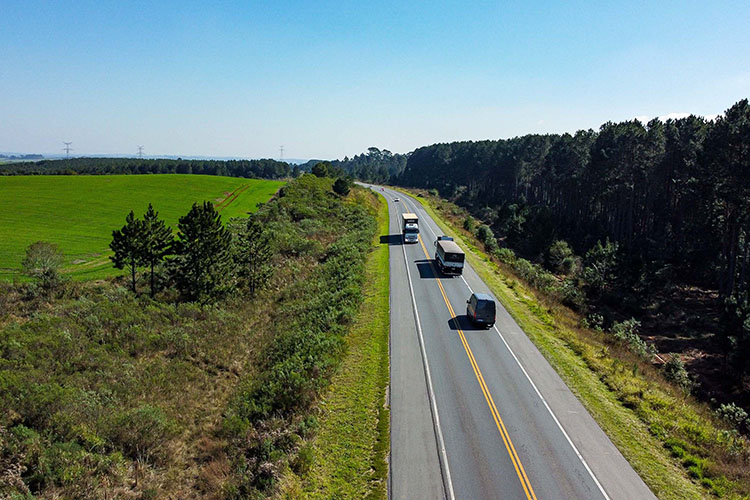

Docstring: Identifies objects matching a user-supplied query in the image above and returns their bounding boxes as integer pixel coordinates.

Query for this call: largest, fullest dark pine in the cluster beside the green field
[173,201,232,302]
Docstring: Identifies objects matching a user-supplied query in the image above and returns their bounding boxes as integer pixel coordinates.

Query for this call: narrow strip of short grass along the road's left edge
[277,189,390,500]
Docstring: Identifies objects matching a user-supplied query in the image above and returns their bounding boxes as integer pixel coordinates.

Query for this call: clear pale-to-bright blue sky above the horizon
[0,0,750,158]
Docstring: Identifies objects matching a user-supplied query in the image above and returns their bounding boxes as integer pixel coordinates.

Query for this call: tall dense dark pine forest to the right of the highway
[390,100,750,392]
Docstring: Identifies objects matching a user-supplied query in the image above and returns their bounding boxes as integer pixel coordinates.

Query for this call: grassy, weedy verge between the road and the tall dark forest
[396,190,750,500]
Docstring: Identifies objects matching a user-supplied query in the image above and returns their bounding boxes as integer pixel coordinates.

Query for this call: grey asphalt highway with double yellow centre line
[364,186,655,500]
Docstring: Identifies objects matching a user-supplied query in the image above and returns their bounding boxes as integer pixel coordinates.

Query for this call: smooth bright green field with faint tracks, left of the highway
[0,174,284,280]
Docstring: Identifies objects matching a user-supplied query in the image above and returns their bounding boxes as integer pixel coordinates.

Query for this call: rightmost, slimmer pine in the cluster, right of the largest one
[235,216,273,295]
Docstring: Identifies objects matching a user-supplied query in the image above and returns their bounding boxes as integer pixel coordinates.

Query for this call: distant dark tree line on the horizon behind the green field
[0,158,299,179]
